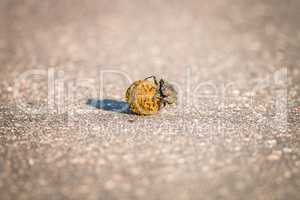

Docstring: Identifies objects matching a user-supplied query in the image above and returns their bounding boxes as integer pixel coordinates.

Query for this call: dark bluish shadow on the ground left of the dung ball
[86,99,130,114]
